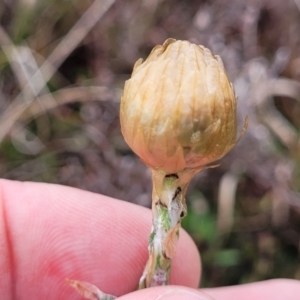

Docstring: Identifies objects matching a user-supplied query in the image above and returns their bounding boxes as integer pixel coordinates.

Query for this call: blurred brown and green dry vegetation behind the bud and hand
[0,0,300,287]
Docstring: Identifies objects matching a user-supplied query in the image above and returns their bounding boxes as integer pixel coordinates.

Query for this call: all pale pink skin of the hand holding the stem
[0,180,300,300]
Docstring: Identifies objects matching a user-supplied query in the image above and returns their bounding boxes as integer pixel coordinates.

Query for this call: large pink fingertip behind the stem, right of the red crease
[0,180,200,299]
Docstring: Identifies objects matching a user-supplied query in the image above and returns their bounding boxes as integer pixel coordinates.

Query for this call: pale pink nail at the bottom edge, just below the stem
[155,288,214,300]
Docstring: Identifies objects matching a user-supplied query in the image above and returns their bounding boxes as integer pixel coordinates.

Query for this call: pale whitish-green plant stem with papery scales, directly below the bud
[139,169,196,289]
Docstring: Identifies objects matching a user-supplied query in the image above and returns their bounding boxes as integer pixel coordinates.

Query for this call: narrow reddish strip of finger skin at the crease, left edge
[0,183,17,300]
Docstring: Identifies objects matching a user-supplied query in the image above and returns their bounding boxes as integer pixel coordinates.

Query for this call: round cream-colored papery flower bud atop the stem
[120,39,237,173]
